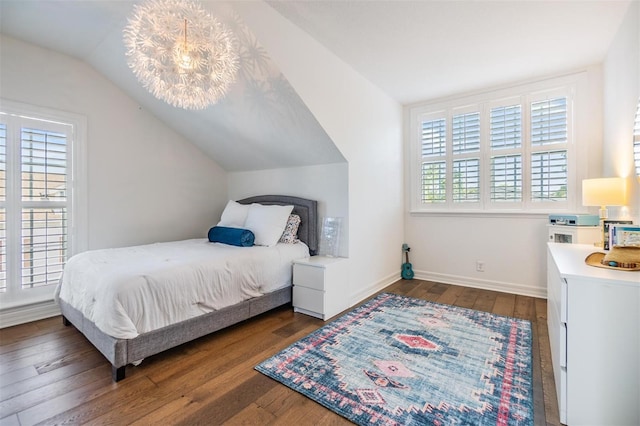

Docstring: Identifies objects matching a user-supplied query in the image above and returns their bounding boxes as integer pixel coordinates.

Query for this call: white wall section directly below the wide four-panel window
[406,214,547,297]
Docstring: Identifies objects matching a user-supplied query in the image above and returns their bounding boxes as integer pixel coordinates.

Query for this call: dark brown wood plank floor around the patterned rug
[0,280,559,425]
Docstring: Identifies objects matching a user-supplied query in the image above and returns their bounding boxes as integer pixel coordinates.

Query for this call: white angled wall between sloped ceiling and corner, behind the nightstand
[234,2,404,303]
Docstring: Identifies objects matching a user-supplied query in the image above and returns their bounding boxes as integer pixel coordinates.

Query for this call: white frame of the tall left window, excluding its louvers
[0,99,88,309]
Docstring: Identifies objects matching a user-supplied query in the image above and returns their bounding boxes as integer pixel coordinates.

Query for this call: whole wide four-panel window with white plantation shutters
[410,78,577,211]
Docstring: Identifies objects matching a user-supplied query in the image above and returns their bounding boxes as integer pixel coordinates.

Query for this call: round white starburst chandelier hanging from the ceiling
[123,0,238,110]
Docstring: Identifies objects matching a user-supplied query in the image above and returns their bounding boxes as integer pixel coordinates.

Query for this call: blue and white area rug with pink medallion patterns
[256,293,533,425]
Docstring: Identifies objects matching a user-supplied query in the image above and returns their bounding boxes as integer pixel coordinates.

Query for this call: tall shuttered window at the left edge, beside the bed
[0,101,84,305]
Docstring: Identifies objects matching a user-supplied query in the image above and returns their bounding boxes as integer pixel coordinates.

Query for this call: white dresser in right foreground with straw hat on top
[547,243,640,426]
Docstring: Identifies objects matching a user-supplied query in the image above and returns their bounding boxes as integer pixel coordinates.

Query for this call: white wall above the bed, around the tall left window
[0,36,227,249]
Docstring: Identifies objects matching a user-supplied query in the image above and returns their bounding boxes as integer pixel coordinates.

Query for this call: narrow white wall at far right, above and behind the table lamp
[594,2,640,223]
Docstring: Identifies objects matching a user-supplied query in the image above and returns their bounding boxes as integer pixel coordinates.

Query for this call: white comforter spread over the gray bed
[56,239,309,339]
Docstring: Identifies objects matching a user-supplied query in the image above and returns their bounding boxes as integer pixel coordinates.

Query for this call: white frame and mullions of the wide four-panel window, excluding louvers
[406,73,586,214]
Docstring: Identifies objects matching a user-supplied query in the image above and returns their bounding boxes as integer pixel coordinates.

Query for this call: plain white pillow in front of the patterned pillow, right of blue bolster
[244,203,293,247]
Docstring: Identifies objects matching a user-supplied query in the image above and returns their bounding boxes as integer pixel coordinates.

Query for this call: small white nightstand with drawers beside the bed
[293,256,349,321]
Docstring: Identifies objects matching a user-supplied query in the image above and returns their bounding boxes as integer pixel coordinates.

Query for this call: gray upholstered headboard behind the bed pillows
[238,195,318,256]
